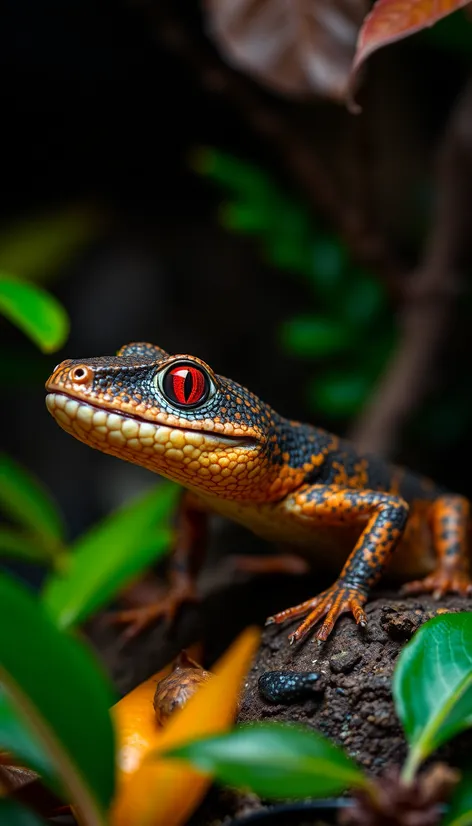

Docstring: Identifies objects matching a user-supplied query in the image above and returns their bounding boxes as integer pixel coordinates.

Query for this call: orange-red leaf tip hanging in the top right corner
[349,0,470,105]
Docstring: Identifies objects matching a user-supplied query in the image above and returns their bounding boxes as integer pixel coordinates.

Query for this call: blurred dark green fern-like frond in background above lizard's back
[192,149,396,420]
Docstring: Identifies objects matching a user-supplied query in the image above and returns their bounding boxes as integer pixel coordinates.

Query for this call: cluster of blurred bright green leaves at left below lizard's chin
[0,448,179,628]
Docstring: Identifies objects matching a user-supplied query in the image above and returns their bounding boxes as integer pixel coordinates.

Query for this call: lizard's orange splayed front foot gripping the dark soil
[266,582,367,645]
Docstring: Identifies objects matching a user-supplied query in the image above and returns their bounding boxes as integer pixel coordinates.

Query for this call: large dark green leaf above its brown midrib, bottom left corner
[0,576,115,826]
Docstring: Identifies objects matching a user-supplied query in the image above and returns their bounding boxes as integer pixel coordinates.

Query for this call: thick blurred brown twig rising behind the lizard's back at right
[351,78,472,455]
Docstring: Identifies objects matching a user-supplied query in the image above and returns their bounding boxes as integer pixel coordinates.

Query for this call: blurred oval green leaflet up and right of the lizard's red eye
[281,316,352,358]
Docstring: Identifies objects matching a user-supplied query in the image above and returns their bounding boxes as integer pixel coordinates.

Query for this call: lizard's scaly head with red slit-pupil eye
[46,343,284,499]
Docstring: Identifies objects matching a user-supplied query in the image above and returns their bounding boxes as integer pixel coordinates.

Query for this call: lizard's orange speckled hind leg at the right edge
[402,494,472,599]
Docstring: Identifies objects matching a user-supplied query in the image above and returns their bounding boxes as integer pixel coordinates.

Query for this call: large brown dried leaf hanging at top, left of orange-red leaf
[205,0,368,100]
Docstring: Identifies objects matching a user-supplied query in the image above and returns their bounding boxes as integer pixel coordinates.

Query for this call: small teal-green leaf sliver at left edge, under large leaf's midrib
[0,686,55,784]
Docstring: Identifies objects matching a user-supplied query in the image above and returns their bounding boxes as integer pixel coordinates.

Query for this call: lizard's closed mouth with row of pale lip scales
[46,391,257,450]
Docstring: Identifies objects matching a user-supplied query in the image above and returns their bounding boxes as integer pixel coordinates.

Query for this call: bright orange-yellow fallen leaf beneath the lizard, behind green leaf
[111,628,260,826]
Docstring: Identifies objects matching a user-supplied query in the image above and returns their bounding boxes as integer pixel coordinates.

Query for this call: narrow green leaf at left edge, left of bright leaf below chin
[0,454,64,553]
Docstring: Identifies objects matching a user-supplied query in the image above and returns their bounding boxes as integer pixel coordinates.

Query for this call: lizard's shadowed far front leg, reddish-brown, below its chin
[113,491,208,639]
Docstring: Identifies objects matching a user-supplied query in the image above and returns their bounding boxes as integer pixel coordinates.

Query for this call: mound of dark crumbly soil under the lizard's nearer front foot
[239,594,472,774]
